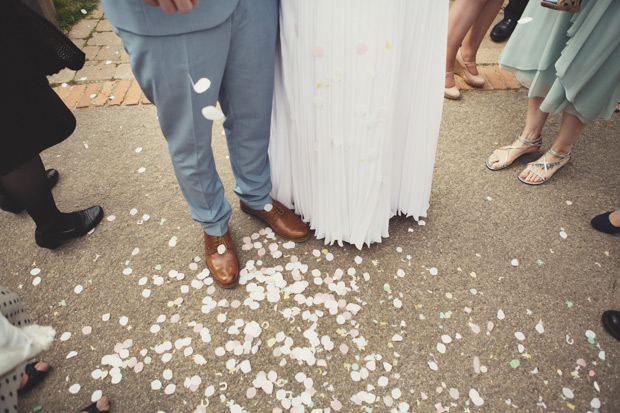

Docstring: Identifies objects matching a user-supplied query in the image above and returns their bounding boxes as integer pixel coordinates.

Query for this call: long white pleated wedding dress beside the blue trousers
[269,0,448,248]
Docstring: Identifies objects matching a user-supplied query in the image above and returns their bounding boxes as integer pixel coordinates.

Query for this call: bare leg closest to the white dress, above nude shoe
[446,0,486,87]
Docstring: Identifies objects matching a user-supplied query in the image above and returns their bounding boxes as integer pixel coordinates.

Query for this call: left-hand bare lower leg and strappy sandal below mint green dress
[489,97,549,169]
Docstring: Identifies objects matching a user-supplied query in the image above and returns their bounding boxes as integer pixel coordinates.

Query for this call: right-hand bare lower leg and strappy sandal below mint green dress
[519,112,587,182]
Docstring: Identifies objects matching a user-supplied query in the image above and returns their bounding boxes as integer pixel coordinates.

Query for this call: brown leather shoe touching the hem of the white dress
[239,199,310,242]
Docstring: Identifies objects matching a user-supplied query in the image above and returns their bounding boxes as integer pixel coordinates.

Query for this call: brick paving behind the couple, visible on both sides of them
[49,5,521,109]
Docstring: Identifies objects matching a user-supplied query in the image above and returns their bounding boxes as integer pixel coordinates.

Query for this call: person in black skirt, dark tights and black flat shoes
[0,0,103,249]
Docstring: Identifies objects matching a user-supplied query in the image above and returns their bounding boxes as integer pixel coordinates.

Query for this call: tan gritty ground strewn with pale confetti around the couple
[0,3,620,413]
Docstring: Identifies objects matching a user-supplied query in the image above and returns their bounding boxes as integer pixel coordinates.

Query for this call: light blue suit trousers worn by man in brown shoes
[117,0,278,236]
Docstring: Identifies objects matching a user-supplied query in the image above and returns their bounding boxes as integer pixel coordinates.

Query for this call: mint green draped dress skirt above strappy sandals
[499,0,620,123]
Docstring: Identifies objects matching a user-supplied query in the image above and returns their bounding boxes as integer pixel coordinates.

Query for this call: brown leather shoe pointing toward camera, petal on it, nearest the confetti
[205,231,239,288]
